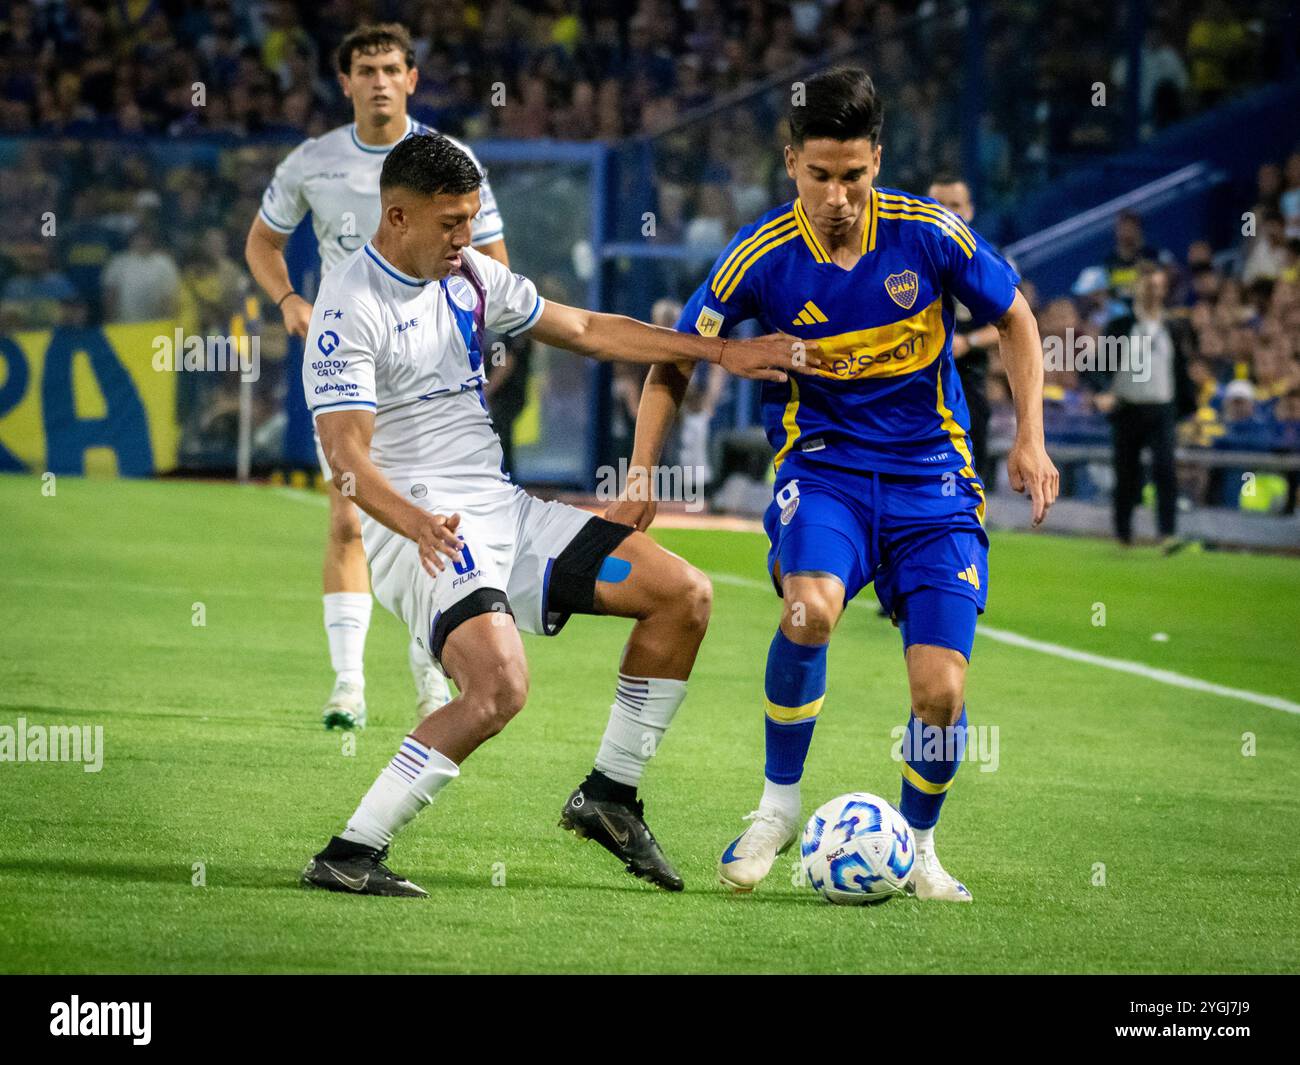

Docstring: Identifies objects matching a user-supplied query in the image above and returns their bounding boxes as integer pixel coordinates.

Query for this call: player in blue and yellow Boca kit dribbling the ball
[606,68,1058,901]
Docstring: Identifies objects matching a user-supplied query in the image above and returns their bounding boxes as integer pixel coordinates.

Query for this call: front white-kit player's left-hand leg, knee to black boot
[303,611,528,897]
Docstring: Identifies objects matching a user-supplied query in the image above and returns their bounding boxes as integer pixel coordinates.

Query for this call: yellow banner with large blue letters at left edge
[0,321,179,477]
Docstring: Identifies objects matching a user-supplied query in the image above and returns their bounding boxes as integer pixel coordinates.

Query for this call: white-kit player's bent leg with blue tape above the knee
[560,532,712,891]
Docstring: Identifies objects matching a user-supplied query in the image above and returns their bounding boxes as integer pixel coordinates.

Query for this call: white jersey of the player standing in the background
[259,116,504,274]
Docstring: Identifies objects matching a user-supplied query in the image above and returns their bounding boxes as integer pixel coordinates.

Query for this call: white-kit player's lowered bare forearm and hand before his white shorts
[316,411,460,576]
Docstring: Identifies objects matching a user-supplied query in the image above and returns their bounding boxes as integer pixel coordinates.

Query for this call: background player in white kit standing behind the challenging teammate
[244,23,510,728]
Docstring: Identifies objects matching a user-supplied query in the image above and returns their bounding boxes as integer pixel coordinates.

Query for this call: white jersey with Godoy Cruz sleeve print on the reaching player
[303,243,543,499]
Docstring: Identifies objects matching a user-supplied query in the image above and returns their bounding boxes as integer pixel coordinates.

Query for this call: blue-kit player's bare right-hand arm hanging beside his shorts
[997,293,1061,525]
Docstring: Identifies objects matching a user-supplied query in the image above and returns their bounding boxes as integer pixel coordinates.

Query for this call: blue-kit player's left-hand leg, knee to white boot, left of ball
[718,573,844,892]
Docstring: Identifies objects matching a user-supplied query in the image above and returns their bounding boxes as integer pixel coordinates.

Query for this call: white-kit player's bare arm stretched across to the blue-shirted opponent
[529,300,820,381]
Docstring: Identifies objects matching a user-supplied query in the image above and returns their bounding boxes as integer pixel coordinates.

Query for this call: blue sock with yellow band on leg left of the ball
[763,629,827,784]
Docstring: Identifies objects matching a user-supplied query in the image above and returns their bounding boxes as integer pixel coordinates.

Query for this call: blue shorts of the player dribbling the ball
[763,455,988,659]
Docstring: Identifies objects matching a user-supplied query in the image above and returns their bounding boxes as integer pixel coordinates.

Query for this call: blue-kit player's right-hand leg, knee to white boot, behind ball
[904,644,972,902]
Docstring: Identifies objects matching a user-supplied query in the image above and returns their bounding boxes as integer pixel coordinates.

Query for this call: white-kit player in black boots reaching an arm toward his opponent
[303,134,819,896]
